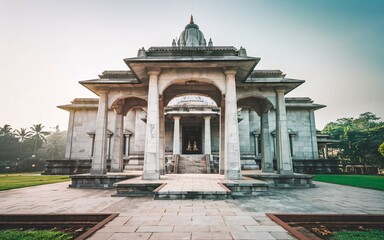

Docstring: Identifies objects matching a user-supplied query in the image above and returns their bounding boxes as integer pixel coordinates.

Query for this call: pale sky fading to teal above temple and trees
[0,0,384,130]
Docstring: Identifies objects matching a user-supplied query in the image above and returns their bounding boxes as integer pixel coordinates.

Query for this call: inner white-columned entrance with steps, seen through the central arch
[164,93,220,173]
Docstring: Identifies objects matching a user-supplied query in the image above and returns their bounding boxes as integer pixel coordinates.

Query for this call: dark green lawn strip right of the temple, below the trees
[313,174,384,191]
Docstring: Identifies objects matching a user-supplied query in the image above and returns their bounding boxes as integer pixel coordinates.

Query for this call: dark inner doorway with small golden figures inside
[182,126,203,154]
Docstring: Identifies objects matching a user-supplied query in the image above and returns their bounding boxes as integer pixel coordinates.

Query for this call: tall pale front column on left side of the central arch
[143,69,160,180]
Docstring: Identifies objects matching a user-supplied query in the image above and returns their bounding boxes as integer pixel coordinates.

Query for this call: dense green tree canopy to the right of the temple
[322,112,384,164]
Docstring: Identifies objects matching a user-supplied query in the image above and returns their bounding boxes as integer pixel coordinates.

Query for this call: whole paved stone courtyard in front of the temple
[0,178,384,240]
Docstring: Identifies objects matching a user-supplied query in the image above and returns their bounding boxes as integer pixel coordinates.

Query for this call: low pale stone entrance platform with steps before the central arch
[113,174,268,200]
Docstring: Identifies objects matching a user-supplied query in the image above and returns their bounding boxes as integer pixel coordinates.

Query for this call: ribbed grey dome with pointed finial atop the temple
[177,15,207,47]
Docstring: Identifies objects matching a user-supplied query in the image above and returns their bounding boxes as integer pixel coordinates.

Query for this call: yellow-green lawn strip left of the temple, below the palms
[0,173,70,191]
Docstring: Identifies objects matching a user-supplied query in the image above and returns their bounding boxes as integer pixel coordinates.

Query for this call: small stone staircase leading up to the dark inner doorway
[177,154,207,174]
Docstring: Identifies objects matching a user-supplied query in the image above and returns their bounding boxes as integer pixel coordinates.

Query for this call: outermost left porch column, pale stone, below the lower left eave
[91,89,109,175]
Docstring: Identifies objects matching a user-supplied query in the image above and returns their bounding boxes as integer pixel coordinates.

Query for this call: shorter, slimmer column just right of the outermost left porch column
[111,106,124,172]
